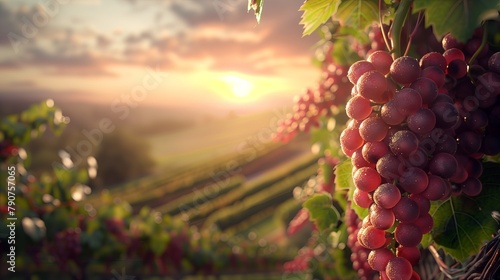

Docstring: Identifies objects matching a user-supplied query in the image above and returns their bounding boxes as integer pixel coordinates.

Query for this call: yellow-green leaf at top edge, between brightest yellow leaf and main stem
[333,0,379,30]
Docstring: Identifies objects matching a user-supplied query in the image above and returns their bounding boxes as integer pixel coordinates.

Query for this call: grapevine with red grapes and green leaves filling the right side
[256,0,500,279]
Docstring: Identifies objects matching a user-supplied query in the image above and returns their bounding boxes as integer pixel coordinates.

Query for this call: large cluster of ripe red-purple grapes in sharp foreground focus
[340,43,500,279]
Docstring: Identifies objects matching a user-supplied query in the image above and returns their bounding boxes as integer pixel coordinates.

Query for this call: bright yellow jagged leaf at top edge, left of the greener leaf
[299,0,341,36]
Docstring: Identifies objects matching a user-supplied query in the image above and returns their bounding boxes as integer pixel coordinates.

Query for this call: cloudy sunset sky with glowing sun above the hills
[0,0,318,115]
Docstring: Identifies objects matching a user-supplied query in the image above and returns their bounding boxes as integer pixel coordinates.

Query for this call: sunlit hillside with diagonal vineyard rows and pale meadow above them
[83,110,318,279]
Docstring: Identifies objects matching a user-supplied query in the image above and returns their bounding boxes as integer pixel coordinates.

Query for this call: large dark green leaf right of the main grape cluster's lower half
[423,162,500,261]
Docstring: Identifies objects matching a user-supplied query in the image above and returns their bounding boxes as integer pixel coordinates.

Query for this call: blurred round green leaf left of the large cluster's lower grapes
[303,193,340,231]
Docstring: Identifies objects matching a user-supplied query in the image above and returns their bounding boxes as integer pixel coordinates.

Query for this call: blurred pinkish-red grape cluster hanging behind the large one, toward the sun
[274,45,352,142]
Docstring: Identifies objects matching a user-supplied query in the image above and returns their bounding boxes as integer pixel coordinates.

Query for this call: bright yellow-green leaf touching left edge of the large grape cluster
[335,159,368,219]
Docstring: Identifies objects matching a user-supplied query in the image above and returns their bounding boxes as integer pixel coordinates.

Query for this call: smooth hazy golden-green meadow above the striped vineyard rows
[149,112,288,170]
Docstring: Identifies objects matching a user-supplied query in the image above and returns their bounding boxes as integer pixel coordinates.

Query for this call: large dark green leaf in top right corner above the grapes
[413,0,500,42]
